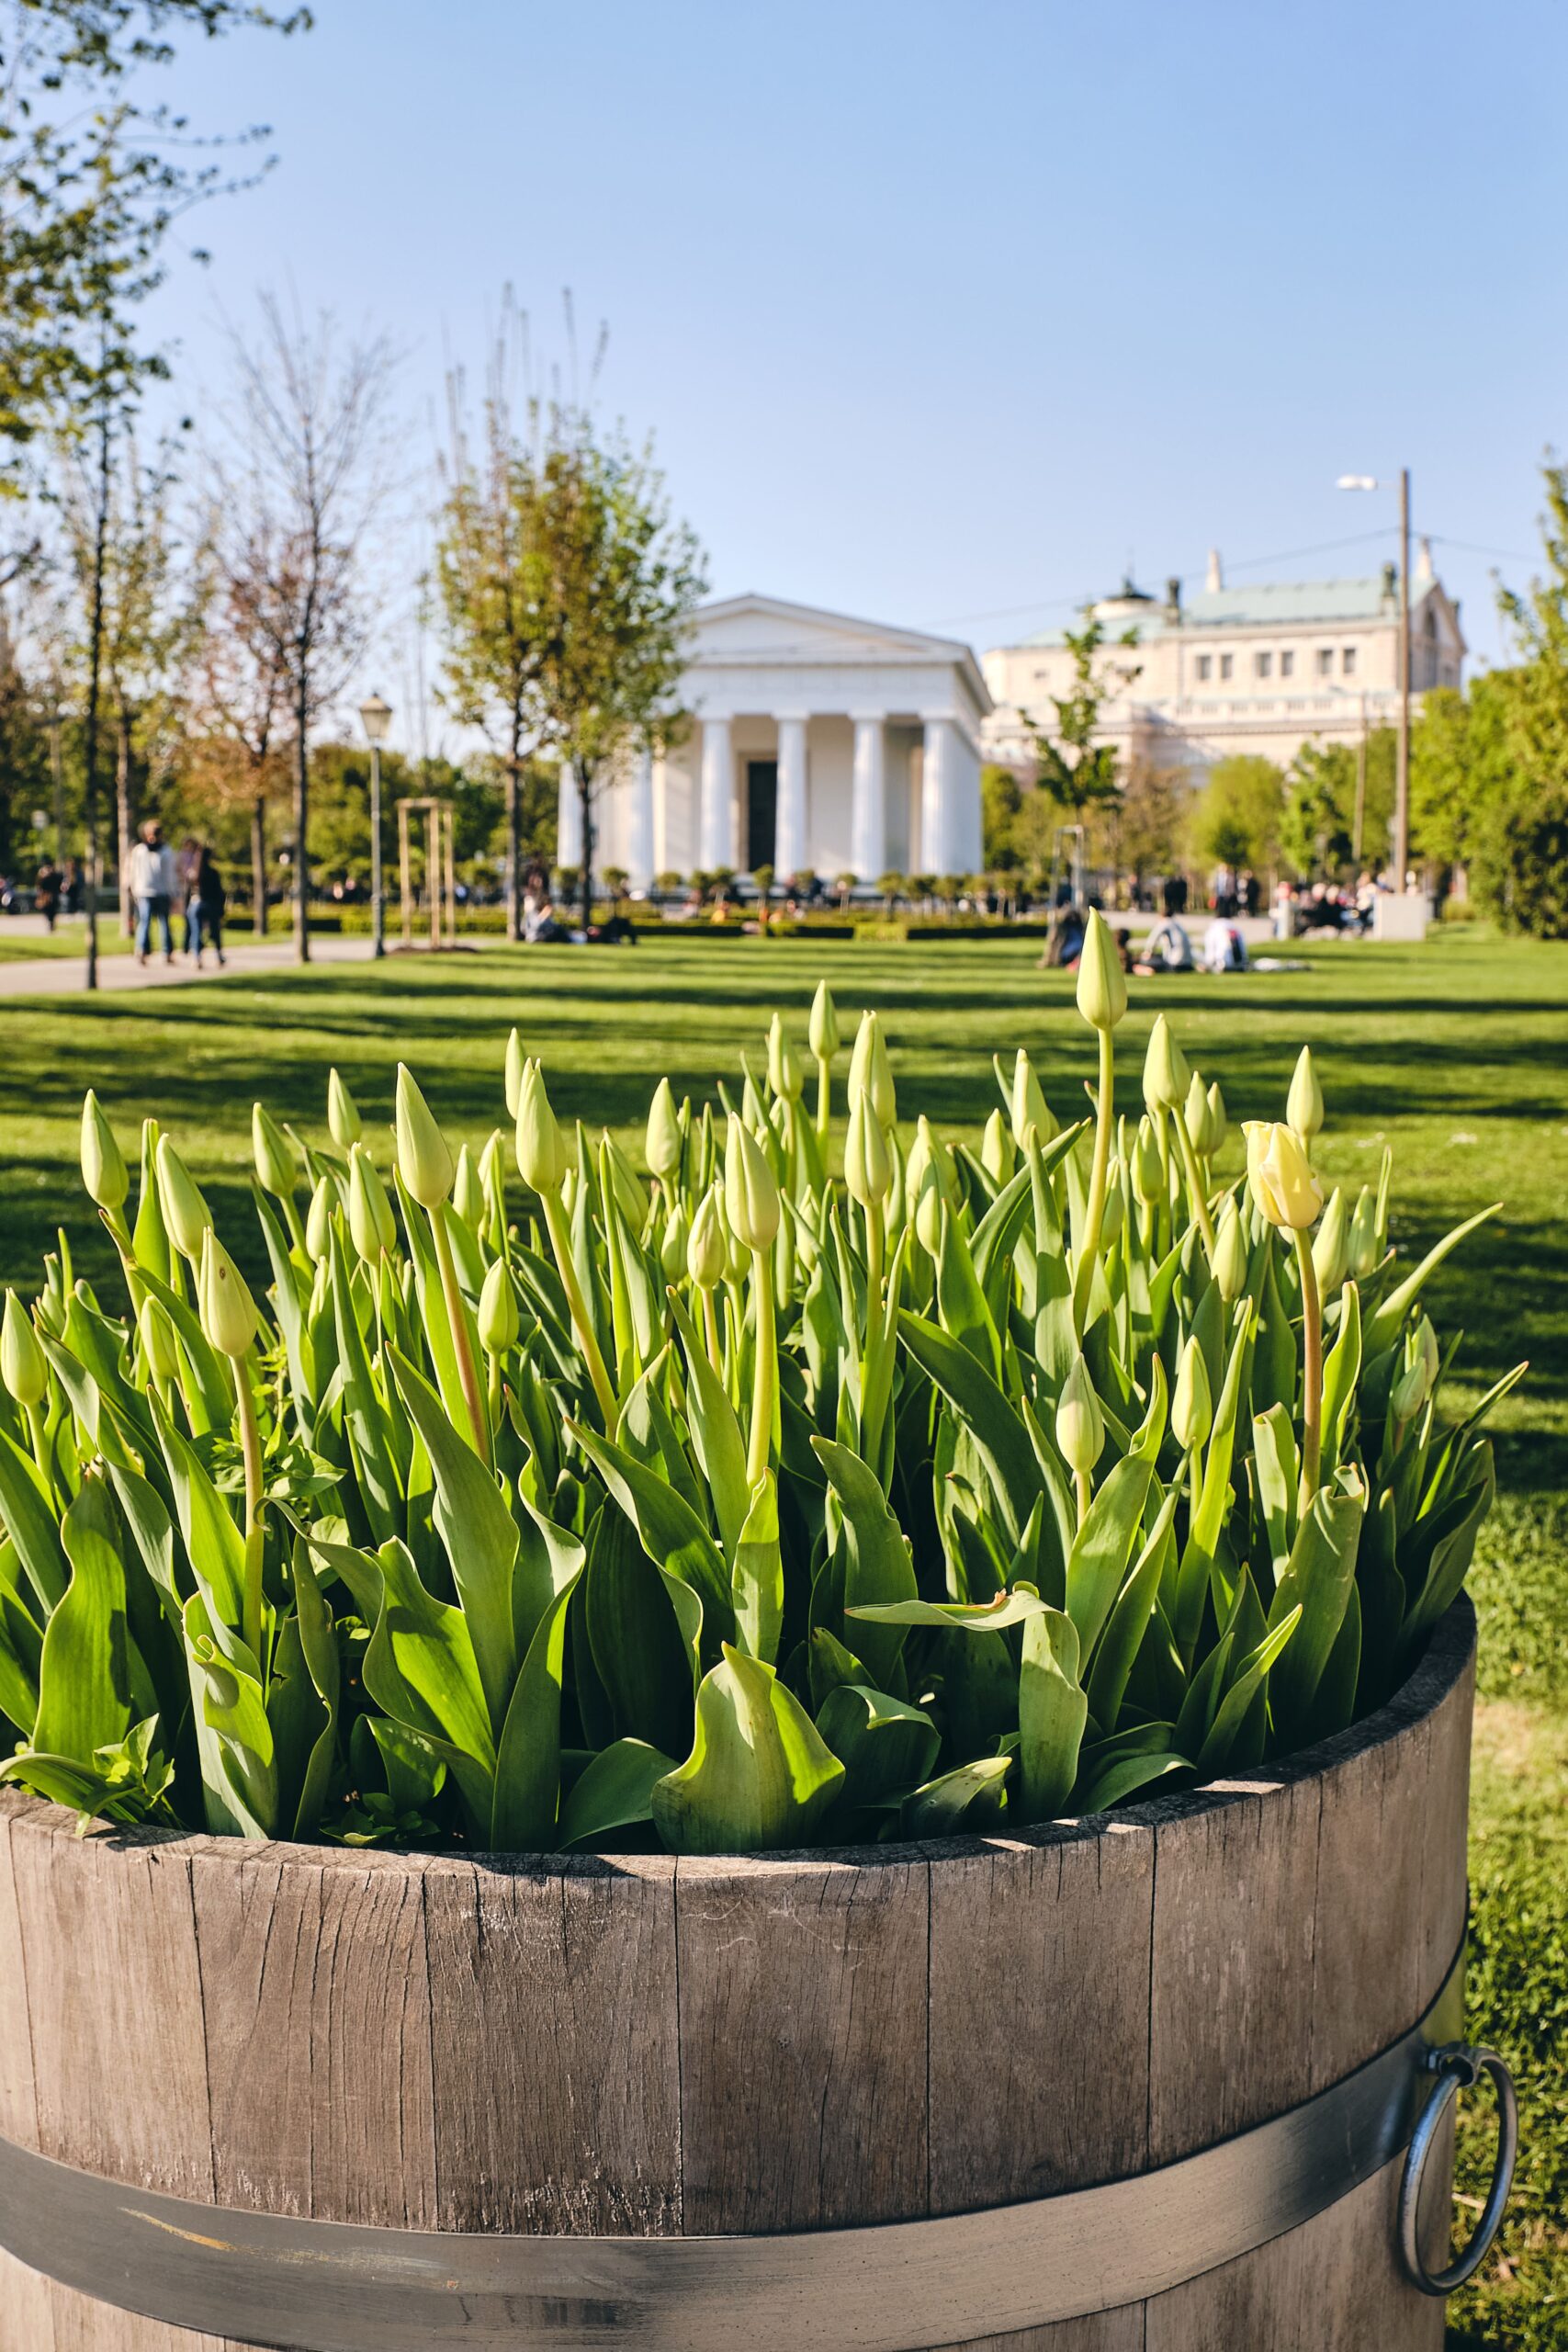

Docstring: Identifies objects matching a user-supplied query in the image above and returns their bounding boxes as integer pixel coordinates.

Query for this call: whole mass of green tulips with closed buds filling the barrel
[0,917,1517,1853]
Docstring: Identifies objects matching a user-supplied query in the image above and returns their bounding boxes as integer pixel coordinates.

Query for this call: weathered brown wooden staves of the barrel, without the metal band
[0,1606,1474,2352]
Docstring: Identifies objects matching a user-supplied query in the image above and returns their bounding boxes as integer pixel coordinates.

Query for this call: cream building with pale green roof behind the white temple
[983,538,1464,783]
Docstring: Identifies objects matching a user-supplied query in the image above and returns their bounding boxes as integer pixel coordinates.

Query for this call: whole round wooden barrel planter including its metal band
[0,1601,1474,2352]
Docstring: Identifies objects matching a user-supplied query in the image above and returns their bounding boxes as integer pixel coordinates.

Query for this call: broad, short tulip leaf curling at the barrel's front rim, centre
[653,1642,844,1853]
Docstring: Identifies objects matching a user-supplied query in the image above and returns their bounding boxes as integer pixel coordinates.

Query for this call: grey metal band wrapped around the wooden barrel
[0,1948,1464,2352]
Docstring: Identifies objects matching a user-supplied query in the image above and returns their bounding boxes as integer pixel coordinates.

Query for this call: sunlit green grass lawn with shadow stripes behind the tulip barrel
[0,929,1568,2352]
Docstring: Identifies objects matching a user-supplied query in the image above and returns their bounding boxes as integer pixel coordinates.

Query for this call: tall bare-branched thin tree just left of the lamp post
[214,294,392,965]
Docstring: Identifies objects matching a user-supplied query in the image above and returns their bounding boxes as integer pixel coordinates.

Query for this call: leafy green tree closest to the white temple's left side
[538,412,705,924]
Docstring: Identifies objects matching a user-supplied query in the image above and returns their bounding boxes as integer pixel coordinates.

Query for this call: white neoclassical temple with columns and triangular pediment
[558,595,992,887]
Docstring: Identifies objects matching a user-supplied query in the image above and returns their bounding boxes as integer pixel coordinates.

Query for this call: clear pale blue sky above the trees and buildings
[141,0,1568,715]
